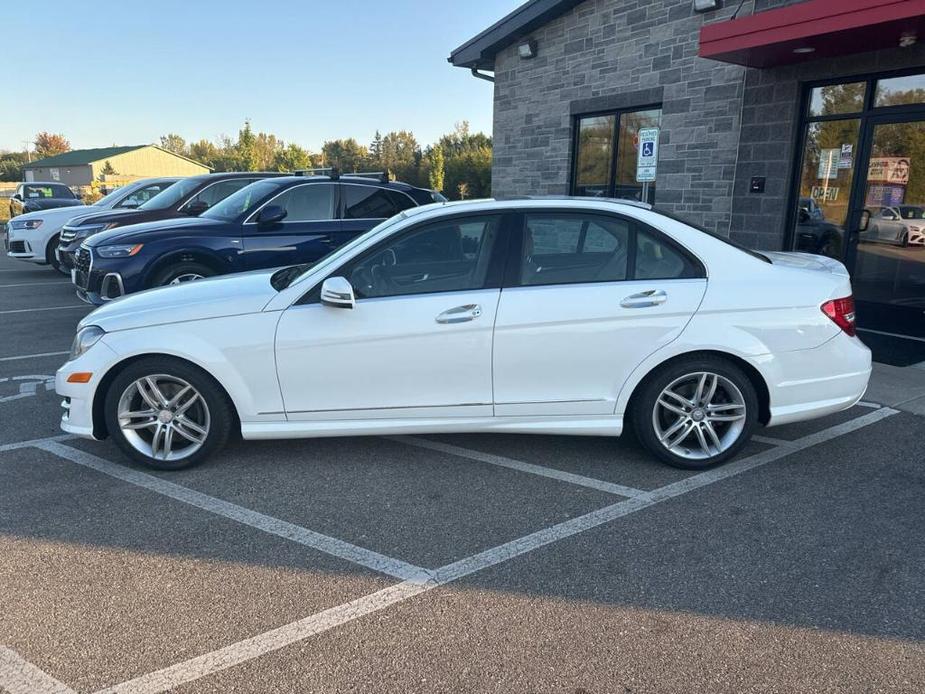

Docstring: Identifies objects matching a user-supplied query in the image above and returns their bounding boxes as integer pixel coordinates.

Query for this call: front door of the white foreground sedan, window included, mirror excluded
[276,214,507,420]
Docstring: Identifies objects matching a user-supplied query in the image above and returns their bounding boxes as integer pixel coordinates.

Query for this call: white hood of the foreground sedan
[79,270,276,332]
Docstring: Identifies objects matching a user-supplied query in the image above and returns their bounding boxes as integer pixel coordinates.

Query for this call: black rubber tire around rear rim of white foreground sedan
[630,355,758,470]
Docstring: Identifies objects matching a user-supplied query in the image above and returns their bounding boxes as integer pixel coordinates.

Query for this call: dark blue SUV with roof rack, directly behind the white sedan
[73,176,442,304]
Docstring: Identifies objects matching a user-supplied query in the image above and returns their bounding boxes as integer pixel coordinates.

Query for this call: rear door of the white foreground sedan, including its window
[494,211,706,416]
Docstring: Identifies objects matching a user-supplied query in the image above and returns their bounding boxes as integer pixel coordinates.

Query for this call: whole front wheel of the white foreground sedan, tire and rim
[104,357,235,470]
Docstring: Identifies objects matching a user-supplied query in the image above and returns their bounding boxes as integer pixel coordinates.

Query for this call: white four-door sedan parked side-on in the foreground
[57,198,871,476]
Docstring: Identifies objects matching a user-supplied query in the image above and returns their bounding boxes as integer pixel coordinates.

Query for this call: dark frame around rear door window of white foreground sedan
[502,207,708,289]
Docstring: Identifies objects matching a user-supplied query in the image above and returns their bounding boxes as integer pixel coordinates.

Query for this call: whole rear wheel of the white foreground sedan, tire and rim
[631,356,758,470]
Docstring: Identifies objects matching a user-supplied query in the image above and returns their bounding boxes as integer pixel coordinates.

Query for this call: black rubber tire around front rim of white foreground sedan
[103,357,237,470]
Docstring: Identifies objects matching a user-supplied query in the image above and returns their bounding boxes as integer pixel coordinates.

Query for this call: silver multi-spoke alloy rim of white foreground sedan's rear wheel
[652,371,746,460]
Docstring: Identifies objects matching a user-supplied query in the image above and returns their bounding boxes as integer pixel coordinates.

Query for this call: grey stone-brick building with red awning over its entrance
[449,0,925,346]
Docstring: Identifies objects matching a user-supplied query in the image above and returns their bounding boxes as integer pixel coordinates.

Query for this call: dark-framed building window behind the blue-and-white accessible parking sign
[572,109,662,203]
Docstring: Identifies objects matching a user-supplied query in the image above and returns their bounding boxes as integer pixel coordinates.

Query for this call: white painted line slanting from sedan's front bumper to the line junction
[33,440,429,582]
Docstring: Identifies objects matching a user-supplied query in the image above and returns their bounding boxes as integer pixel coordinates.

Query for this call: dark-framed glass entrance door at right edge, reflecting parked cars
[846,116,925,337]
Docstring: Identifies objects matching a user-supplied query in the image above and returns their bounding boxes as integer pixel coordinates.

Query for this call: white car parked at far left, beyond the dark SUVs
[7,178,179,270]
